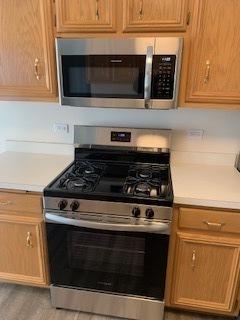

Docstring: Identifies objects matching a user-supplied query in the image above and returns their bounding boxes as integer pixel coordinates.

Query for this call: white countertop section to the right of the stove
[171,163,240,210]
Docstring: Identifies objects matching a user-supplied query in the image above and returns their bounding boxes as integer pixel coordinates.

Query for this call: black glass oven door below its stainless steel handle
[46,215,169,301]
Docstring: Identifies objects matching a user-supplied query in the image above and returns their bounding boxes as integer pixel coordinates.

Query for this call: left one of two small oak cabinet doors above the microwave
[56,0,117,33]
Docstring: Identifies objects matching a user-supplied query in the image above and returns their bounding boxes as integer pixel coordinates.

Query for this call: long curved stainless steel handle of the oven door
[45,212,171,234]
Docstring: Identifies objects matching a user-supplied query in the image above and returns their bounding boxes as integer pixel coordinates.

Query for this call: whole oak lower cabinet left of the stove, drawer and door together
[0,192,49,286]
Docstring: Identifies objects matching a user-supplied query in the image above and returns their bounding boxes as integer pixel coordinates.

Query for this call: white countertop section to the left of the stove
[0,152,73,192]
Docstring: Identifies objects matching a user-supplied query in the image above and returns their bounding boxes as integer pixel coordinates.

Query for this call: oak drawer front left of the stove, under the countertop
[0,192,42,214]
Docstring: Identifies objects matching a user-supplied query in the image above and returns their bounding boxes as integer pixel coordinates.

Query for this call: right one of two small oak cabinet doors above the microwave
[123,0,188,32]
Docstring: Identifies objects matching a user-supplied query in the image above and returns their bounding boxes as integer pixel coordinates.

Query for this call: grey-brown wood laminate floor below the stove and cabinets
[0,283,237,320]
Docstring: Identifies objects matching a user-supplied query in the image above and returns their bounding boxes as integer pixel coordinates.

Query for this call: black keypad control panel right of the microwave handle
[151,55,176,100]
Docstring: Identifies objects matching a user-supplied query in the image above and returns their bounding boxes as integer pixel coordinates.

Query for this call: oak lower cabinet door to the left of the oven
[0,218,47,285]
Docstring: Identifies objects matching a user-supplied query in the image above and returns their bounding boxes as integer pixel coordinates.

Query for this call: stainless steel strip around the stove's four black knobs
[44,197,172,221]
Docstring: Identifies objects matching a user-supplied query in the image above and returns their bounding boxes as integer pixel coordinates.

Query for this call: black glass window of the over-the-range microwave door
[61,55,146,99]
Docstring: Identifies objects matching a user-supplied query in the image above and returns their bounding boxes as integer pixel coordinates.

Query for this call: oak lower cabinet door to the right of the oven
[171,233,240,314]
